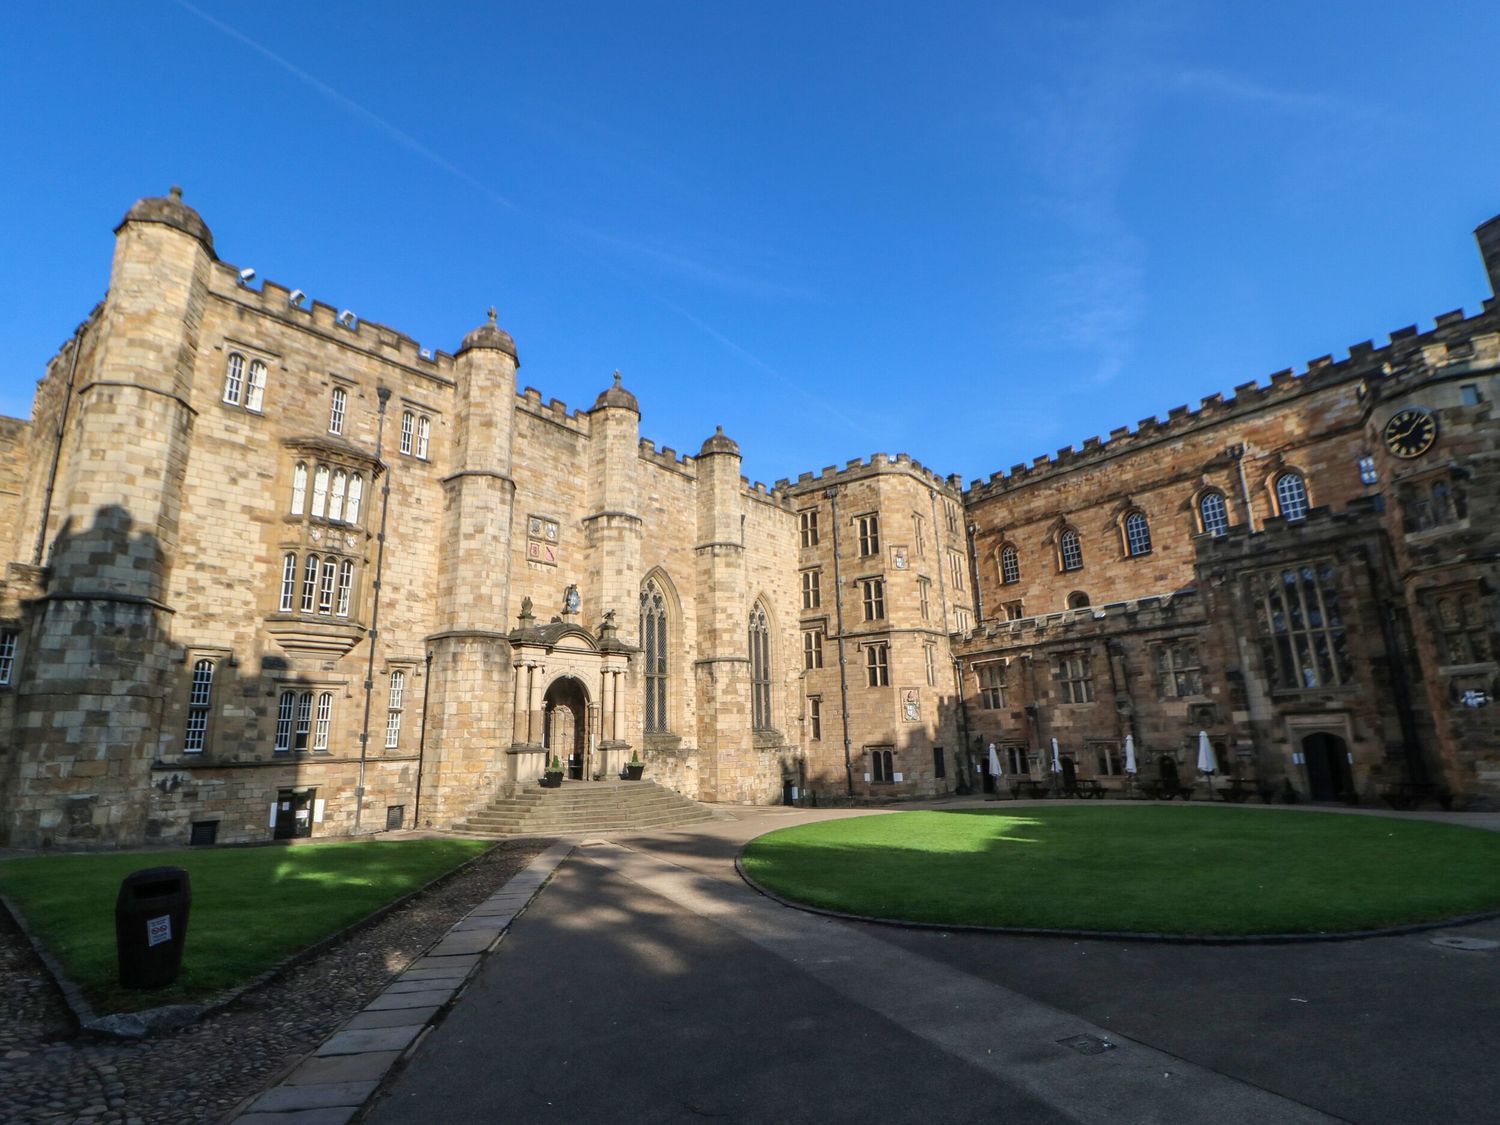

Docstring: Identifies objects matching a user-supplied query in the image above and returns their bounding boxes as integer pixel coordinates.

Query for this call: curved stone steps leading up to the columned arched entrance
[453,782,713,836]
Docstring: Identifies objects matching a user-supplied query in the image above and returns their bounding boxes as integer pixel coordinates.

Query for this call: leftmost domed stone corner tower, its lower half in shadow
[12,189,215,846]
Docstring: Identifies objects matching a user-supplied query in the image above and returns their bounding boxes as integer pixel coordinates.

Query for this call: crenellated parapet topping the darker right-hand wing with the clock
[960,302,1500,503]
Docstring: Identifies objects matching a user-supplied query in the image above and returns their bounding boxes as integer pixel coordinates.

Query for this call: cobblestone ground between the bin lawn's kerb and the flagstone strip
[0,840,551,1125]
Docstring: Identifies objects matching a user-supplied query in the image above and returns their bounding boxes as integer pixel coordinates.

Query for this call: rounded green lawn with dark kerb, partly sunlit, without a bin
[743,806,1500,935]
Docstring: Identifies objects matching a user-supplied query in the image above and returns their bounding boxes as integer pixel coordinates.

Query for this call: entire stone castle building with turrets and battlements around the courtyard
[0,189,1500,846]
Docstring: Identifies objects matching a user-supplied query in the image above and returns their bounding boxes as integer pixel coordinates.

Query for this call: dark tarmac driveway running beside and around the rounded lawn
[242,804,1500,1125]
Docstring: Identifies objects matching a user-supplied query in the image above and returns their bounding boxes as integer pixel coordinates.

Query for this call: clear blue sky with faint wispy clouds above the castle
[0,0,1500,482]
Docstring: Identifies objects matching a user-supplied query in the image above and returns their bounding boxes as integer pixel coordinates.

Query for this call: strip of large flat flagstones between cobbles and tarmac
[231,840,575,1125]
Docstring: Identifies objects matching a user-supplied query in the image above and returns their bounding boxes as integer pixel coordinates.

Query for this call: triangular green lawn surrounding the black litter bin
[0,840,491,1013]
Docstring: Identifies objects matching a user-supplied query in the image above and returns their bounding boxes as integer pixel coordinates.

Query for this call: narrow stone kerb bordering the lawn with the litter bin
[0,840,501,1040]
